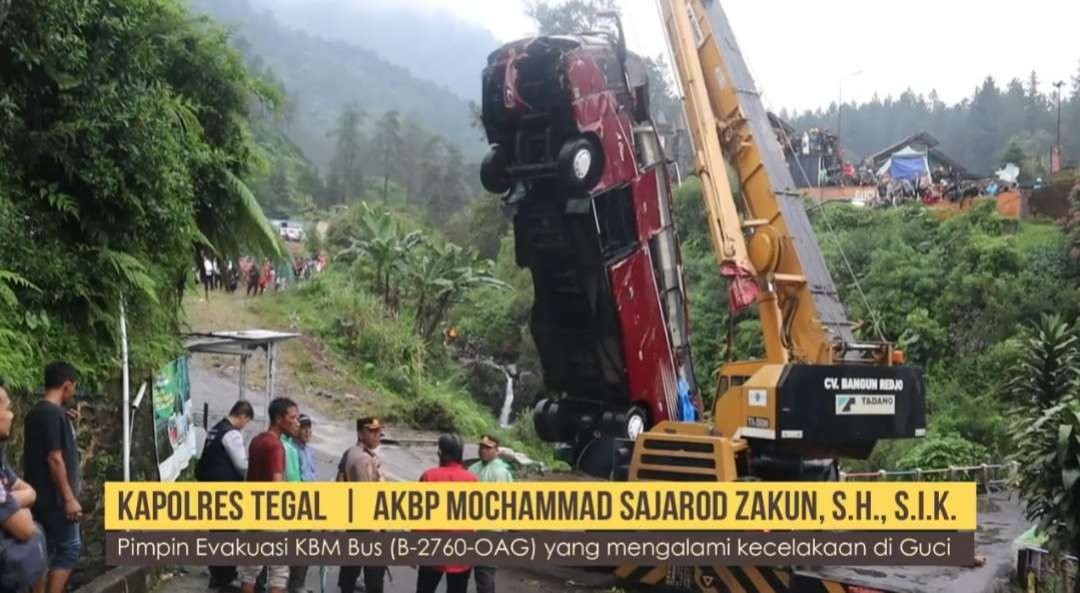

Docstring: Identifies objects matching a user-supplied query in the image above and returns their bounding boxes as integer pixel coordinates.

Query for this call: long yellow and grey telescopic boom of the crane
[661,0,854,364]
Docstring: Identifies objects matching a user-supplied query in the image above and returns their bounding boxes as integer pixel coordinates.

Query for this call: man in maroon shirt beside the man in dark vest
[239,397,300,593]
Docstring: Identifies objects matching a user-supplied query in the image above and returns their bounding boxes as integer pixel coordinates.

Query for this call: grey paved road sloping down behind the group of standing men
[183,355,612,593]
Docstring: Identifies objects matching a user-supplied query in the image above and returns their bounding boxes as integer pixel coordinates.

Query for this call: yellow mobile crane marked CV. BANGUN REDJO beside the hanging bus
[630,0,926,490]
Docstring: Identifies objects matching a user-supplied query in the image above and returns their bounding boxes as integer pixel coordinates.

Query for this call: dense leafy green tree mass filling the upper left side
[0,0,280,580]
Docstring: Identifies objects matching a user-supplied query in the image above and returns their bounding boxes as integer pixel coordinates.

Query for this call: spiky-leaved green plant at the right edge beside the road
[1011,316,1080,591]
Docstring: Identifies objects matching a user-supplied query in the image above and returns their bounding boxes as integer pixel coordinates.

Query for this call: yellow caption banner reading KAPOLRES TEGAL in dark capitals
[105,482,975,531]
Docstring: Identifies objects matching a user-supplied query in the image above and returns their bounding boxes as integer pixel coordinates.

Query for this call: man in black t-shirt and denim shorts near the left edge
[23,362,82,593]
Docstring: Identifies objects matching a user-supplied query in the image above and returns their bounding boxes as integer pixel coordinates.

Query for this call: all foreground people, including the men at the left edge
[0,362,513,593]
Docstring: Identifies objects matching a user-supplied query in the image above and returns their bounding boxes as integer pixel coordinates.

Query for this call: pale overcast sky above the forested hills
[406,0,1080,110]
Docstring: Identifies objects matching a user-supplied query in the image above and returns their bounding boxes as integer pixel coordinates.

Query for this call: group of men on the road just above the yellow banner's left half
[195,397,513,593]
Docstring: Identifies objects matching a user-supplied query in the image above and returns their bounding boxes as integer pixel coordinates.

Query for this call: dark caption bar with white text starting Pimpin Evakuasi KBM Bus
[106,531,975,566]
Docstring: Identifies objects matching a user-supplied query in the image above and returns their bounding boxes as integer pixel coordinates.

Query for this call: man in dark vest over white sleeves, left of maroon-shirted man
[195,400,255,592]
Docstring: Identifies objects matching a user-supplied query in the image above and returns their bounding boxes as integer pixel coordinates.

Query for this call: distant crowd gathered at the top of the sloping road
[195,251,327,300]
